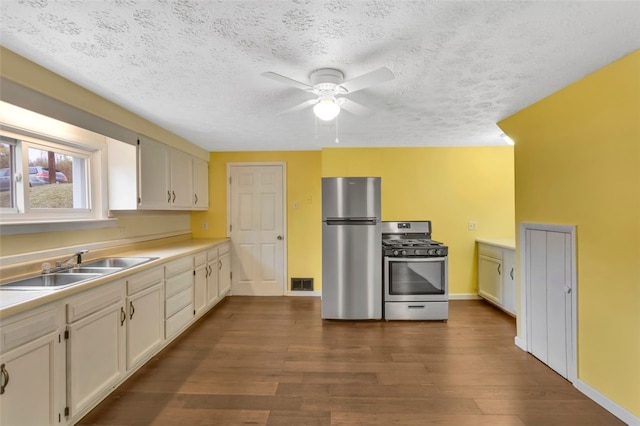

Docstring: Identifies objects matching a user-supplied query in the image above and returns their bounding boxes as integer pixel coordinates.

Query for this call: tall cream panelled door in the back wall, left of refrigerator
[228,163,286,296]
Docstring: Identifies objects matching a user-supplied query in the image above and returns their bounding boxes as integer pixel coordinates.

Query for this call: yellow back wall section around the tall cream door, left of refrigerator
[191,151,322,290]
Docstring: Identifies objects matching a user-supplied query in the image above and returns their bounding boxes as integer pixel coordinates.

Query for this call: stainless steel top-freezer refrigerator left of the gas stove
[322,177,382,320]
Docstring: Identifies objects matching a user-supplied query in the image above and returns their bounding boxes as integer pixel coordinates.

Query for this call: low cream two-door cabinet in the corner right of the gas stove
[478,243,516,315]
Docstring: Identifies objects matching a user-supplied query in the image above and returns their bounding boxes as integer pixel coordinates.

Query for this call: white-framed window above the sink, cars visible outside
[0,104,106,225]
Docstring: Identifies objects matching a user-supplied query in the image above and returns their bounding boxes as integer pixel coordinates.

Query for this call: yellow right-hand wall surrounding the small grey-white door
[499,51,640,416]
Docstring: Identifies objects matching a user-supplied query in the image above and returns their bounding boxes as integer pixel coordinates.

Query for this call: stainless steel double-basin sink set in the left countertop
[0,257,157,290]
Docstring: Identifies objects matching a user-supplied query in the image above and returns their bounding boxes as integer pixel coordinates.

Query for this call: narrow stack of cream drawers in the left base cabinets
[164,256,194,340]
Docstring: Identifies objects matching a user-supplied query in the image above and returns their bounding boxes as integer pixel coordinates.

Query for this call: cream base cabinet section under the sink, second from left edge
[66,281,127,417]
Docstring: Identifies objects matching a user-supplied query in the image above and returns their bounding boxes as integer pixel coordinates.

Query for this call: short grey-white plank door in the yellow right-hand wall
[524,225,575,381]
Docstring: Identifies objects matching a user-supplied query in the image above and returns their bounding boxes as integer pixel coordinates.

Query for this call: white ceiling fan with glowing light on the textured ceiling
[261,67,394,121]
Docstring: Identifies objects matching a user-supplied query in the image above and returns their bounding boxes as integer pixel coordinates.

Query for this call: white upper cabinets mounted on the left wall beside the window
[107,136,209,210]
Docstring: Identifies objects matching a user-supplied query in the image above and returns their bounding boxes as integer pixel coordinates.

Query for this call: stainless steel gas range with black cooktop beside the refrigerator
[382,220,449,321]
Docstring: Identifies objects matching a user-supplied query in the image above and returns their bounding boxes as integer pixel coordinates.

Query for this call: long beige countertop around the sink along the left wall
[0,238,229,318]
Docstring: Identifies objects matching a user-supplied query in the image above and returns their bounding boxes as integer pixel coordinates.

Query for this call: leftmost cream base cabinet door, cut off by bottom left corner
[0,332,62,426]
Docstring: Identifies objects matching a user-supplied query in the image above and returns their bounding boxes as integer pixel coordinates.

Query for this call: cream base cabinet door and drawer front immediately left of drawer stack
[127,268,164,370]
